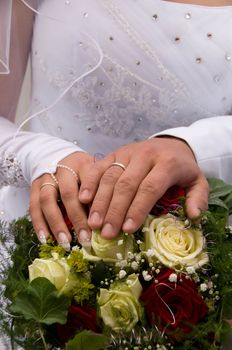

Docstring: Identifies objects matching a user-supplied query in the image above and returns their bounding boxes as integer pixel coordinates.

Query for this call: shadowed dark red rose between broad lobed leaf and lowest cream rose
[57,305,97,344]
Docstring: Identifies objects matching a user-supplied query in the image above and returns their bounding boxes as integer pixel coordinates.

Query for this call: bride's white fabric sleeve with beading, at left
[0,117,82,187]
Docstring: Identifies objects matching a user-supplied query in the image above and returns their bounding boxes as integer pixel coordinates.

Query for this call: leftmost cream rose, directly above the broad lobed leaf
[28,253,77,294]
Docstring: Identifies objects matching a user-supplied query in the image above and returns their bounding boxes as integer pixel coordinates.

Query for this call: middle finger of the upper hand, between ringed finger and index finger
[97,158,150,238]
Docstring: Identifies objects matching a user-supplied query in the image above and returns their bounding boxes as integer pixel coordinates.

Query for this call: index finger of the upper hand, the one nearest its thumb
[122,165,172,233]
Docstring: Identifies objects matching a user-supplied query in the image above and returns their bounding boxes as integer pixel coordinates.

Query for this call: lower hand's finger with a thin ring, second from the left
[40,182,71,251]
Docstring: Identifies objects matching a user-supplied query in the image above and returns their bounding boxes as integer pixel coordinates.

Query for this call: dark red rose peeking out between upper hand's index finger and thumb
[151,186,185,216]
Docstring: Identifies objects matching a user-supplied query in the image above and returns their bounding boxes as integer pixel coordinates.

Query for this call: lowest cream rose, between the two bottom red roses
[98,274,143,333]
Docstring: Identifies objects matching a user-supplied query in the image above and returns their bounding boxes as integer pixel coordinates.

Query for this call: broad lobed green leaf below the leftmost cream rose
[10,277,70,325]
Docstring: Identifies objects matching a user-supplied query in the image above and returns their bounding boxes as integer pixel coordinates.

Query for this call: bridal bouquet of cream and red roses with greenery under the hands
[0,179,232,350]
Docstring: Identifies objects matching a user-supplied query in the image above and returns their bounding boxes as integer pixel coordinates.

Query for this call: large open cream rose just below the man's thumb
[144,214,209,269]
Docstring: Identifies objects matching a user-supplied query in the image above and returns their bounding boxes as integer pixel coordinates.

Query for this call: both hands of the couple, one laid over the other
[30,136,209,250]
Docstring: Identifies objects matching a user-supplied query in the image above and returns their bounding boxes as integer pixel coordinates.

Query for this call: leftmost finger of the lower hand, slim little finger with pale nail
[29,183,50,244]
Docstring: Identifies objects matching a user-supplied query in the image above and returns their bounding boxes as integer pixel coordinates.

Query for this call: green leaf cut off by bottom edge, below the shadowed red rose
[65,330,107,350]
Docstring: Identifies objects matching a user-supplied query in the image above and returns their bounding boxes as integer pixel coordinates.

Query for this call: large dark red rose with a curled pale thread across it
[141,269,208,333]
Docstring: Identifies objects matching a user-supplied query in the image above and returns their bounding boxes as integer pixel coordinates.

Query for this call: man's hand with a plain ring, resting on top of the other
[79,137,208,238]
